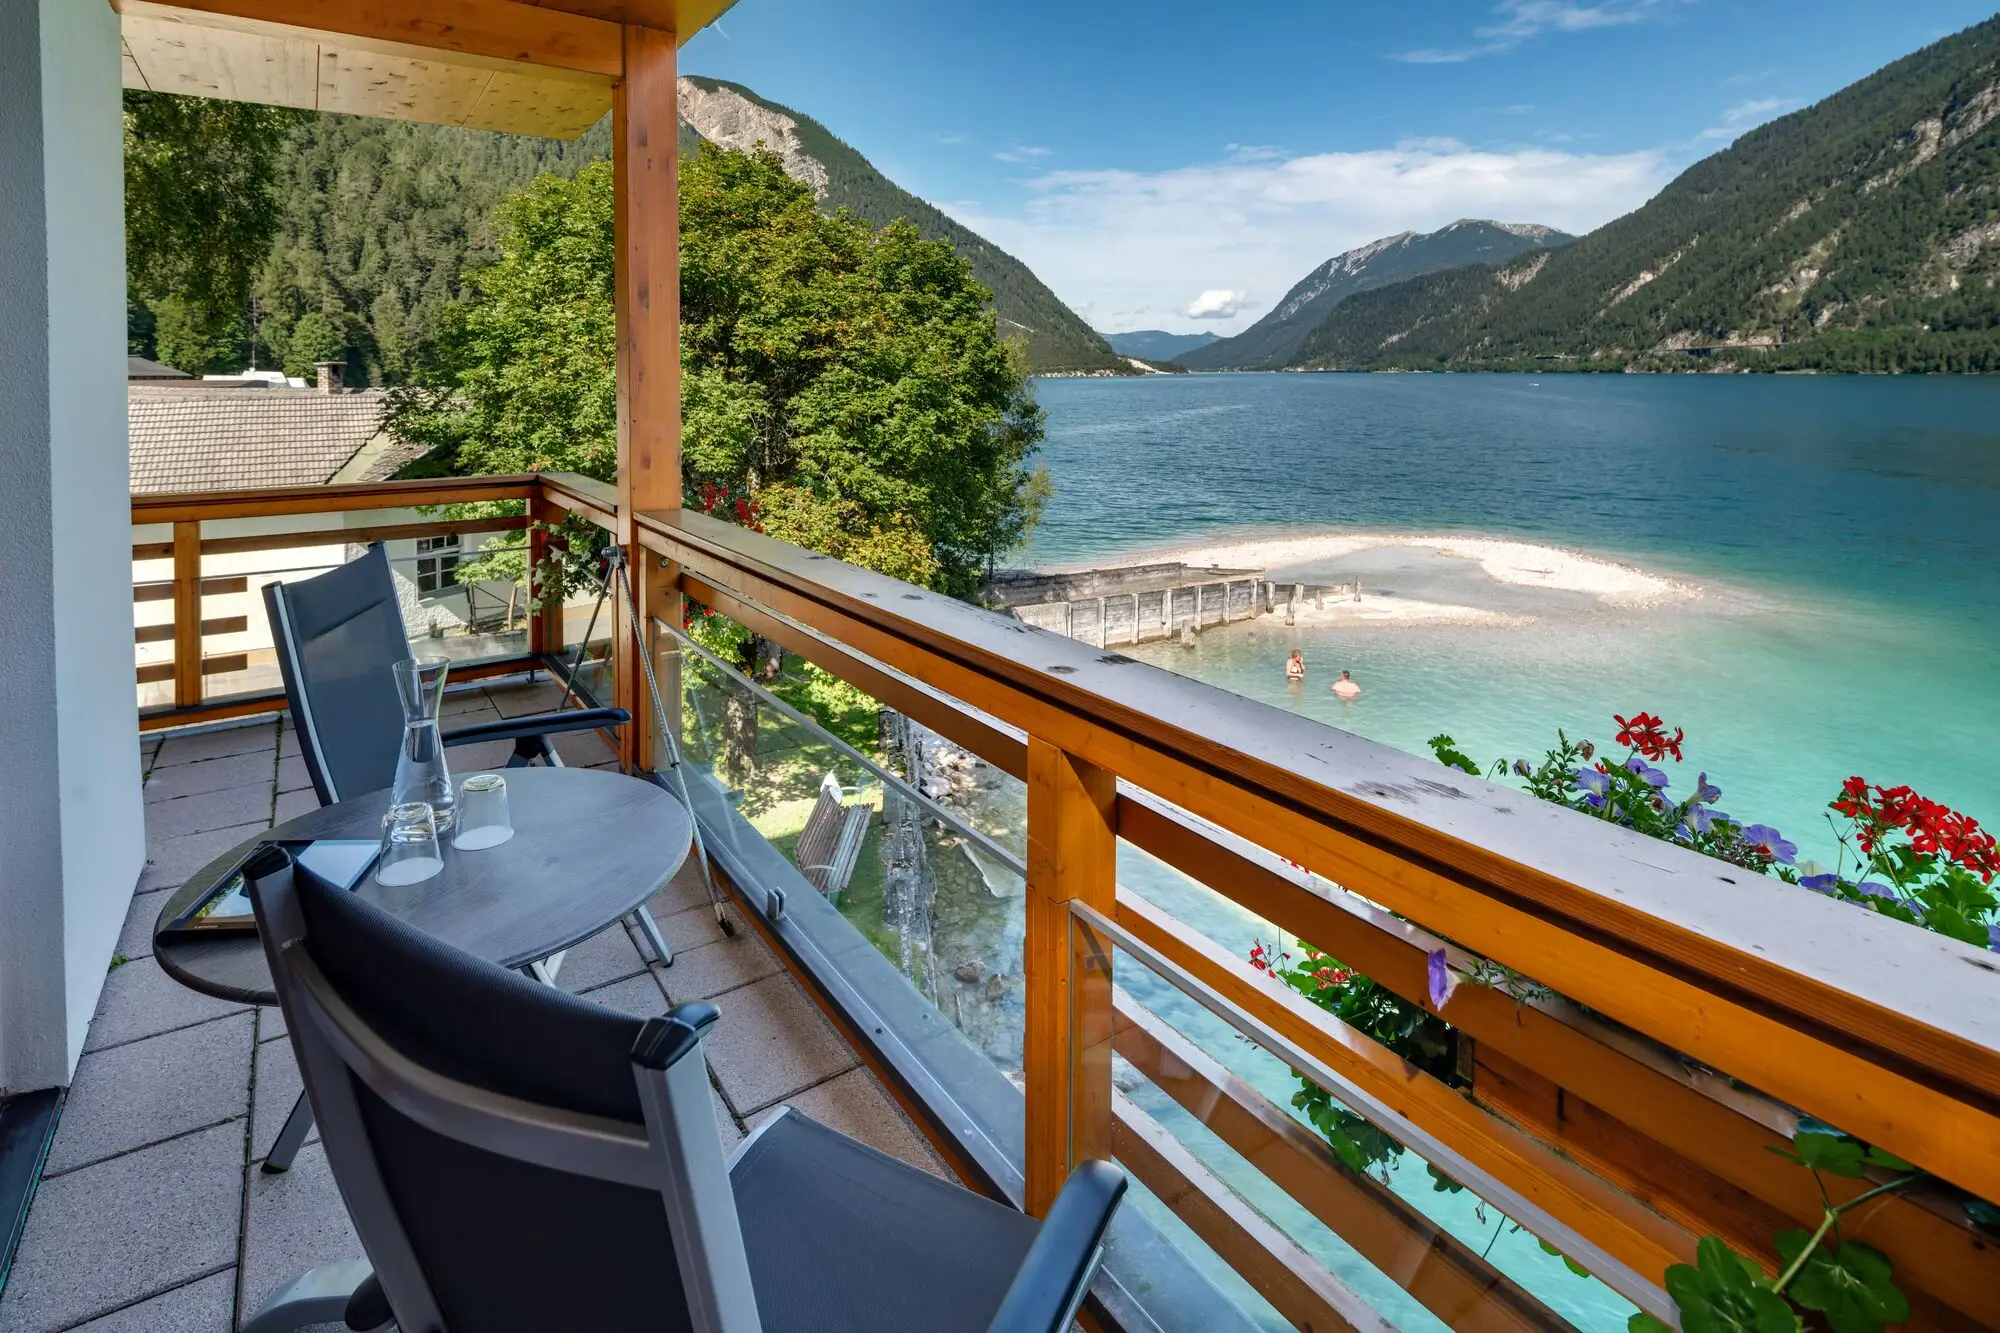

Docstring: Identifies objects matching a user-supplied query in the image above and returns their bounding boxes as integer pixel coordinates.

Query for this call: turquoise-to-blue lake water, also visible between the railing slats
[1022,374,2000,1333]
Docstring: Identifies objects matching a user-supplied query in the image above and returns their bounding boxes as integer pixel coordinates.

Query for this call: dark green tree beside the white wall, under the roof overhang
[124,92,296,374]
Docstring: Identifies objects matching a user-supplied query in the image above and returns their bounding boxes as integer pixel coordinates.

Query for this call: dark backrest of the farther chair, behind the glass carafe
[264,542,410,805]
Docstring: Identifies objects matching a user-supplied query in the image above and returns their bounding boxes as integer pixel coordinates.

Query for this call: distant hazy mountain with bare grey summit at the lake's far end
[1176,218,1574,370]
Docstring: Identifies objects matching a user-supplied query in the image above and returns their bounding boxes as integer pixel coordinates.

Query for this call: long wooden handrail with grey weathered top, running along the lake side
[636,500,2000,1197]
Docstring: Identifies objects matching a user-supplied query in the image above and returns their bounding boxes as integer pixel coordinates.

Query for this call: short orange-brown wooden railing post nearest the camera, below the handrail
[1024,737,1118,1217]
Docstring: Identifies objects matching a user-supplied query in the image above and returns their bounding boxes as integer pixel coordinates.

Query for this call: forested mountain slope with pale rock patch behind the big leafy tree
[160,80,1132,384]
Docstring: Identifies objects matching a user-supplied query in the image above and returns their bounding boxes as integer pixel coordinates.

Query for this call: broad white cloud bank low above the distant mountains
[946,142,1674,332]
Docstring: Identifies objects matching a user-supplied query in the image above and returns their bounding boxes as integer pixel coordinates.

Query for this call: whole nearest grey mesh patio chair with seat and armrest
[244,849,1126,1333]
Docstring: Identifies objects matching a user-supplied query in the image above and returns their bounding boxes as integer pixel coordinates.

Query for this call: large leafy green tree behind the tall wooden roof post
[390,146,1046,594]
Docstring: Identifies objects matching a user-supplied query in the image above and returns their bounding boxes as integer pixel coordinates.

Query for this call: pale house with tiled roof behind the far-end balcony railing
[126,376,526,707]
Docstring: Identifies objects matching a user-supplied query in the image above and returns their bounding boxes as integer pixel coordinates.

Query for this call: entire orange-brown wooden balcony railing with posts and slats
[145,476,2000,1331]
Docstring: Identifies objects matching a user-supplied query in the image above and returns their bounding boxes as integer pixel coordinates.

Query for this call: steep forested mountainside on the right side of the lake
[1294,18,2000,370]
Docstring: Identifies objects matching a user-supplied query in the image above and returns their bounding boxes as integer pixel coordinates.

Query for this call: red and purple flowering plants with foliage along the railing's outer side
[1250,711,2000,1333]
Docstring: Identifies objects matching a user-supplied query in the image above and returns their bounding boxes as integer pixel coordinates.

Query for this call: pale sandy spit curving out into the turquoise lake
[1040,532,1702,624]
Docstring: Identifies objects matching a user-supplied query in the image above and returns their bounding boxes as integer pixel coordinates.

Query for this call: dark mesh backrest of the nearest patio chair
[250,849,758,1333]
